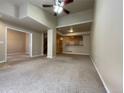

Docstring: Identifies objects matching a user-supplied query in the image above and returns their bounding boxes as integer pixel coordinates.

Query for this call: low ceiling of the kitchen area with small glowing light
[57,22,92,34]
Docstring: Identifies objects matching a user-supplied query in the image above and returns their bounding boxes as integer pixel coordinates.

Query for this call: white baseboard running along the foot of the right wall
[90,55,110,93]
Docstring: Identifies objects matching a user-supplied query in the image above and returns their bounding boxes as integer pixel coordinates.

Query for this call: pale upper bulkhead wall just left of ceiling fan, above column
[27,3,57,29]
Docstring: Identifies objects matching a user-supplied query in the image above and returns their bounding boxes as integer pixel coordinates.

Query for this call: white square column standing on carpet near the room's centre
[47,29,56,58]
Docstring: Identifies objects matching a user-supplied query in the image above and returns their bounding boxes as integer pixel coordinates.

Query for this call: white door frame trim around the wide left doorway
[5,26,33,62]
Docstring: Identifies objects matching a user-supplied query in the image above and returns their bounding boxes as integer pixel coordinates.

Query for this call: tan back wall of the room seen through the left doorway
[7,29,26,53]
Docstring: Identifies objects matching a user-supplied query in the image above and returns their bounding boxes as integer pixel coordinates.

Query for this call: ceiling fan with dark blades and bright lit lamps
[43,0,74,16]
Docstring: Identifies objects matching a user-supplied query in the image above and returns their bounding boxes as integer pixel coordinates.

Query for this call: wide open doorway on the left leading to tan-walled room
[6,27,32,62]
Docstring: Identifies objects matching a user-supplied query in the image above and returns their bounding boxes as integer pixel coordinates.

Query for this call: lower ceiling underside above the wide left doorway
[1,15,48,31]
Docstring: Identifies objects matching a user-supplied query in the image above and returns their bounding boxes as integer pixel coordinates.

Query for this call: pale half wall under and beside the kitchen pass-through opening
[63,34,90,55]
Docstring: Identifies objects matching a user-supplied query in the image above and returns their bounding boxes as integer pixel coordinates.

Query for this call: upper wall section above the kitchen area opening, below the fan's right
[58,9,93,27]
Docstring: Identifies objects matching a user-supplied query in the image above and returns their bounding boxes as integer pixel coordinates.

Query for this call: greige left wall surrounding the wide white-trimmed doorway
[0,21,43,62]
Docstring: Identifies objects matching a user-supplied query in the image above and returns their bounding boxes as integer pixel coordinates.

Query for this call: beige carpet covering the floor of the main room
[0,55,106,93]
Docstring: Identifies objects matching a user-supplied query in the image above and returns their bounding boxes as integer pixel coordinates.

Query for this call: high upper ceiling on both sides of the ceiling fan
[3,0,94,15]
